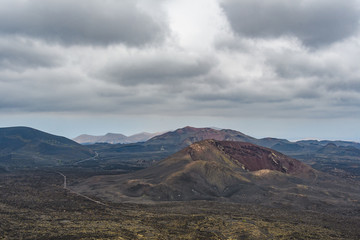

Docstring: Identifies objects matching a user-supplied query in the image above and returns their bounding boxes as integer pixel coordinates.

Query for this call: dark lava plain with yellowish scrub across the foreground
[0,171,360,239]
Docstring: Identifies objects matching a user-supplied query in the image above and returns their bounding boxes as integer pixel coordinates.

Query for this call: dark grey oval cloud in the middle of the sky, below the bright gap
[99,51,216,85]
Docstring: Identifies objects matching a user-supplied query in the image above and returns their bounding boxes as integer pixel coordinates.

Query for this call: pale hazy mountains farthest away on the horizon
[73,132,162,145]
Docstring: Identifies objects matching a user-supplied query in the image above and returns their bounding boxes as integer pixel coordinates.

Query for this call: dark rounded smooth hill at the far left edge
[0,127,94,169]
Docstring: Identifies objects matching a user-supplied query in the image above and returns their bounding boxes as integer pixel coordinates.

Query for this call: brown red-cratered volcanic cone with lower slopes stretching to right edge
[71,140,360,214]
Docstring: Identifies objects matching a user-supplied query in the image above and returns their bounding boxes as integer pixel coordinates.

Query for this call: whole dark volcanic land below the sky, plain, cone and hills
[0,127,360,239]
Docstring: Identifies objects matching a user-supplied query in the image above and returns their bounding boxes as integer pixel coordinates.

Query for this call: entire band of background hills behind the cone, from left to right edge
[0,127,360,179]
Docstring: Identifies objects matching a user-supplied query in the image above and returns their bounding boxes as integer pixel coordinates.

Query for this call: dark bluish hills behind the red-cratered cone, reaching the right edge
[89,126,360,179]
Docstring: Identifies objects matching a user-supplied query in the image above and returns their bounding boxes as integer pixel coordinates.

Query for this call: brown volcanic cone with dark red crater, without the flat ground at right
[75,140,340,204]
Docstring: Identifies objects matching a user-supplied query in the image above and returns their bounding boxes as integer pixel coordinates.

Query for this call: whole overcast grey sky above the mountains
[0,0,360,141]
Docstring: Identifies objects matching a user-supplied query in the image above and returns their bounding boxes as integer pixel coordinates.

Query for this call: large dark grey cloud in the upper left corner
[0,0,167,46]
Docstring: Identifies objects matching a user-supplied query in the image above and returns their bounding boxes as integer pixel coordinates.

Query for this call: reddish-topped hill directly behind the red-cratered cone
[84,127,256,168]
